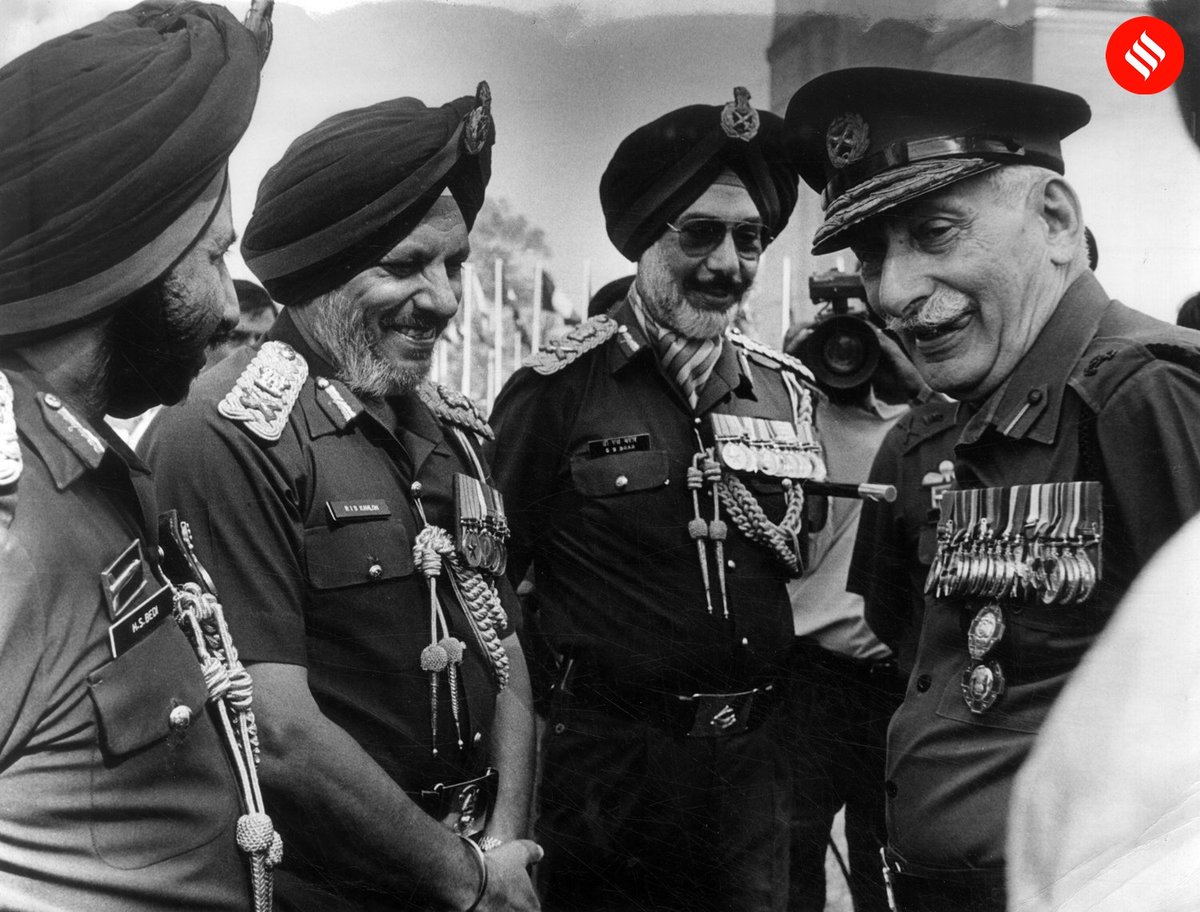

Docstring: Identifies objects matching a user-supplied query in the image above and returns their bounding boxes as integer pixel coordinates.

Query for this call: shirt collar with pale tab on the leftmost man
[2,358,111,491]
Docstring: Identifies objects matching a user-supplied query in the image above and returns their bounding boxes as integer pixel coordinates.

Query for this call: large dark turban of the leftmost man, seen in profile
[0,2,260,336]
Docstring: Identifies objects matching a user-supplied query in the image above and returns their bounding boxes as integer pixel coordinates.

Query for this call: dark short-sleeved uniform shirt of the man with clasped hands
[143,313,520,907]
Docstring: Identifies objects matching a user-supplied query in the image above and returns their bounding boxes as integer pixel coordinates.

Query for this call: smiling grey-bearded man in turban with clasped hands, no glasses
[143,83,541,912]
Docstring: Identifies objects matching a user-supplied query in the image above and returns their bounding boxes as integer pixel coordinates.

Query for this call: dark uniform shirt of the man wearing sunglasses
[491,300,793,694]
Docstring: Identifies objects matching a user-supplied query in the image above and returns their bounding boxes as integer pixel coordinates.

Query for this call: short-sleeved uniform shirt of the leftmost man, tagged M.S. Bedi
[0,359,252,912]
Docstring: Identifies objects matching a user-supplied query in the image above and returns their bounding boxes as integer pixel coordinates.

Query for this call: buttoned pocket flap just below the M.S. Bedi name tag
[88,620,208,756]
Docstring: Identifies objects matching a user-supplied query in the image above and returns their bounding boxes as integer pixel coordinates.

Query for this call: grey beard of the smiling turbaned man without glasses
[308,289,432,400]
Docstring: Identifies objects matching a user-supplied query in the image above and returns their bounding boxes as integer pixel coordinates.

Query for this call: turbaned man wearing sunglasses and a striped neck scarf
[492,89,823,912]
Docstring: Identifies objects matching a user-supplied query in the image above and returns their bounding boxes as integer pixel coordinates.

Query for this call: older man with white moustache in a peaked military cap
[786,68,1200,912]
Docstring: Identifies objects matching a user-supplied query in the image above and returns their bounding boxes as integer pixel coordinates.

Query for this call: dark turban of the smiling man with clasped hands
[241,83,496,305]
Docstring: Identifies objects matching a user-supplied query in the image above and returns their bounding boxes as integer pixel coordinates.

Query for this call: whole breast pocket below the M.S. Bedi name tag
[88,622,238,870]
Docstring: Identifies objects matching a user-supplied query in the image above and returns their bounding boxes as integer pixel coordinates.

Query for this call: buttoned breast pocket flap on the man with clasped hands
[304,517,414,589]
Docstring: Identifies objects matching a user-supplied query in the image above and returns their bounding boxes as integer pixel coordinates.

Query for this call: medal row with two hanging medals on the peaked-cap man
[925,481,1103,713]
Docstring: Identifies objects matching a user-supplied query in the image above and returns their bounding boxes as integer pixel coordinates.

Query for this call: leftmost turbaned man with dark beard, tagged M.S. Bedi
[0,2,272,912]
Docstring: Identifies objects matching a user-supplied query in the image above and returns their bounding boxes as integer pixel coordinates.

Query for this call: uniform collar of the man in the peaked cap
[959,271,1110,444]
